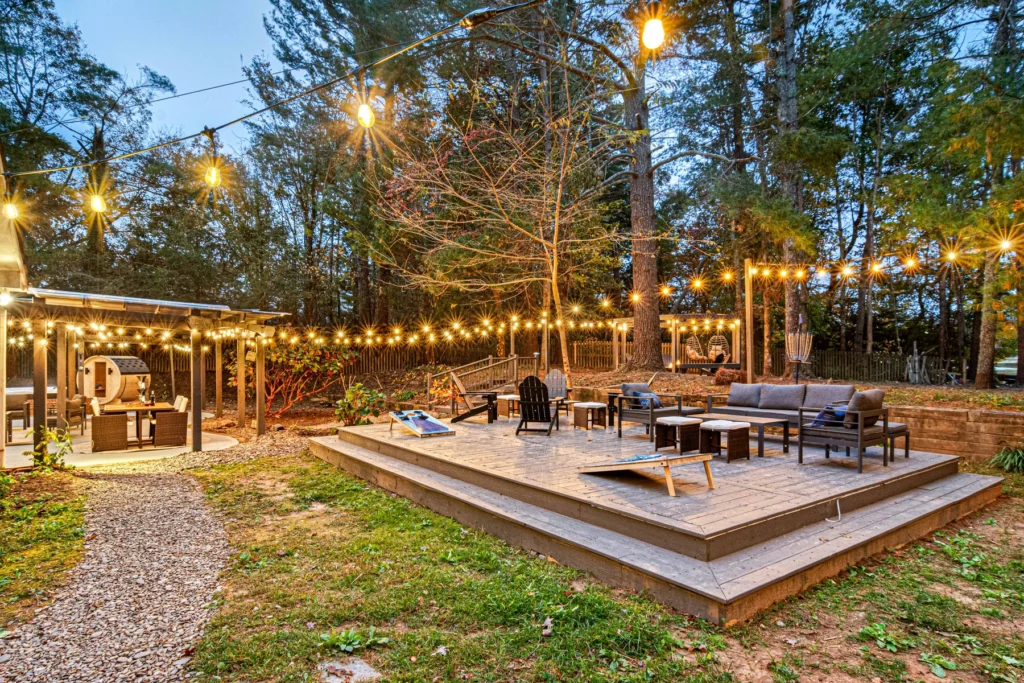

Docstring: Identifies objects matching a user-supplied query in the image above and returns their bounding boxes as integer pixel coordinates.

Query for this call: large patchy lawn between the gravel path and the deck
[191,454,1024,683]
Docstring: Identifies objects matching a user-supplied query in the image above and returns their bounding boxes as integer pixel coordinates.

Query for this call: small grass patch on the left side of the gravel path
[0,472,85,632]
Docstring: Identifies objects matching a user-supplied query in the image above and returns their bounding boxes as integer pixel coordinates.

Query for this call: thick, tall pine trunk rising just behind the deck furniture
[623,74,665,370]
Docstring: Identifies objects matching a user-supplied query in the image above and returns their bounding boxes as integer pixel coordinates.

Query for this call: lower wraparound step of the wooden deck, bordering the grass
[310,437,1001,624]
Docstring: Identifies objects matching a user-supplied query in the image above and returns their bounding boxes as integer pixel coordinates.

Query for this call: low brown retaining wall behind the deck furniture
[572,387,1024,460]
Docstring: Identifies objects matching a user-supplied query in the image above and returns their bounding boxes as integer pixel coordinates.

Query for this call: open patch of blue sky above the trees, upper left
[55,0,272,148]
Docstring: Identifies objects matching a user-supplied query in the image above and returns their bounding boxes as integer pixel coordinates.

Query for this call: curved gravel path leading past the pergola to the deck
[0,432,307,683]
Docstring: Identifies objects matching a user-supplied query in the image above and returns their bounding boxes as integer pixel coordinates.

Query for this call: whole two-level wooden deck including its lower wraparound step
[311,411,1001,623]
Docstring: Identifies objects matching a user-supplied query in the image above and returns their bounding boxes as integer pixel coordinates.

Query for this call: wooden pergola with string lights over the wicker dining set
[0,288,287,453]
